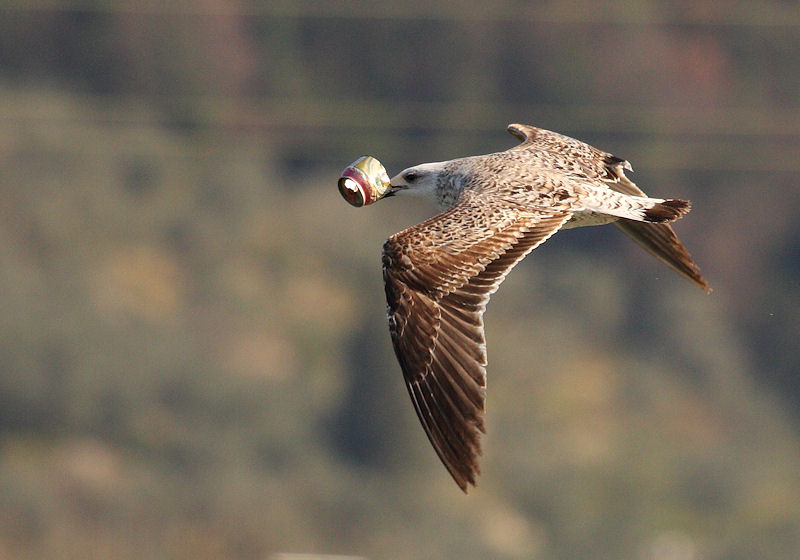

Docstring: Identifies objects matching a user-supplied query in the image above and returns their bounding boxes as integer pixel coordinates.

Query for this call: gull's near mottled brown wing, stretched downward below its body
[383,196,570,492]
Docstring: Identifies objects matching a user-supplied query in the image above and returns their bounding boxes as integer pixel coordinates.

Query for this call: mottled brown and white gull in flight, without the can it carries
[382,124,710,493]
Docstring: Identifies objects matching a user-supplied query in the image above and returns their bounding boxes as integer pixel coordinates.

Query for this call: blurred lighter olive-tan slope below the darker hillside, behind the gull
[0,86,800,558]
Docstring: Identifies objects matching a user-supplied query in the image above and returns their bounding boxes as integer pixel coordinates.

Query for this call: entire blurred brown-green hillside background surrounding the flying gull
[0,0,800,560]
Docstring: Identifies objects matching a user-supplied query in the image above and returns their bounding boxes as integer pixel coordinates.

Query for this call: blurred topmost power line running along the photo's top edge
[0,0,800,28]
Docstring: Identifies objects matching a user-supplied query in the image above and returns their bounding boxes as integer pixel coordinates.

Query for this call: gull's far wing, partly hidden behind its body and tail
[508,124,711,292]
